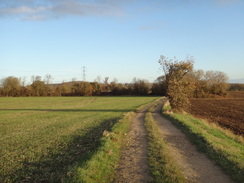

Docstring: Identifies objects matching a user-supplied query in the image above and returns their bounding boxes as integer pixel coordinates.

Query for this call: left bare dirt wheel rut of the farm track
[114,105,151,183]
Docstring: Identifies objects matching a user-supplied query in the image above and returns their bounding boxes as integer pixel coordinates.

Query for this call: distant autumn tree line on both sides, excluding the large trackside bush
[0,70,231,98]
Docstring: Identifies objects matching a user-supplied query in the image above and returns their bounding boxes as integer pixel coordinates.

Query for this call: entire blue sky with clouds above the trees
[0,0,244,83]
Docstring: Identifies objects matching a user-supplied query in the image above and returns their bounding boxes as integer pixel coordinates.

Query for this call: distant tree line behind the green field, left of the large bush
[0,75,152,97]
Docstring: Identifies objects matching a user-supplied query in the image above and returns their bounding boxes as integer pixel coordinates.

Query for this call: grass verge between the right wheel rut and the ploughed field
[163,103,244,182]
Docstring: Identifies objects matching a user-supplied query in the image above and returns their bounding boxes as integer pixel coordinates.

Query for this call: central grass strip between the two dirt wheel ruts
[145,103,186,183]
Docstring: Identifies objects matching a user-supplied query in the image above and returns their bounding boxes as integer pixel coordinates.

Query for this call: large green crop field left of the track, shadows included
[0,97,156,182]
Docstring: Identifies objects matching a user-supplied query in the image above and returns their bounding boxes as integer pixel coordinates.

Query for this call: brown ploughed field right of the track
[188,92,244,135]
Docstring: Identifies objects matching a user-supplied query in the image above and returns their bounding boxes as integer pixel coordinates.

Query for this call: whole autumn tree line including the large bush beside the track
[0,56,233,102]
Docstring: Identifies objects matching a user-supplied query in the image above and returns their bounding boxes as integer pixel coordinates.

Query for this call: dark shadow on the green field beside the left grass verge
[4,118,119,183]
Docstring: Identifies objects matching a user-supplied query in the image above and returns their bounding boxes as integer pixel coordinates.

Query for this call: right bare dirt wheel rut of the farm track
[154,101,232,183]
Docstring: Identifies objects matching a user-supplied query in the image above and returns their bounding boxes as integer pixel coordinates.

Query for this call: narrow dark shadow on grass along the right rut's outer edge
[161,111,244,182]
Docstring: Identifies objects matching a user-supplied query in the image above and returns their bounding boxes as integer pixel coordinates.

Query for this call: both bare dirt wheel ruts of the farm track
[114,101,233,183]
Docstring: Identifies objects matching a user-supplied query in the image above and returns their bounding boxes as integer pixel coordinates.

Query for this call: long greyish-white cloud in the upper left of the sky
[0,0,127,20]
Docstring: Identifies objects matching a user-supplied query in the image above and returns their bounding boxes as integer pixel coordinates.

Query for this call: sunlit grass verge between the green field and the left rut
[64,102,157,183]
